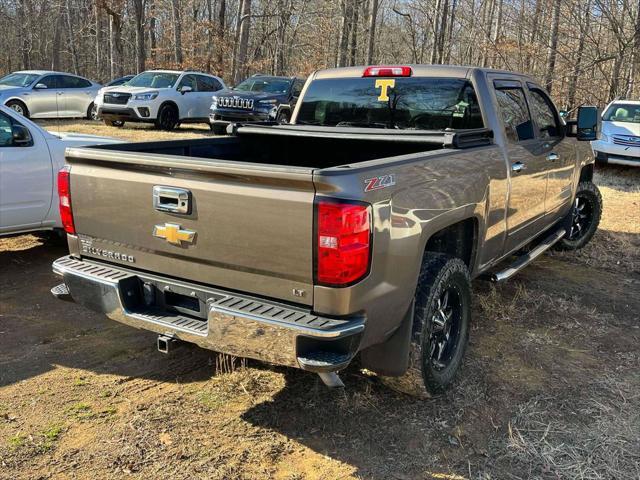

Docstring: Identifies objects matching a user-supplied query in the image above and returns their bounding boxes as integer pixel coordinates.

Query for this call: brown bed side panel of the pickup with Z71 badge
[314,146,508,348]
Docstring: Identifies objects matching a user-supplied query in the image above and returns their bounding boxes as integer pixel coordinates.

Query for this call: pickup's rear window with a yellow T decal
[296,77,484,130]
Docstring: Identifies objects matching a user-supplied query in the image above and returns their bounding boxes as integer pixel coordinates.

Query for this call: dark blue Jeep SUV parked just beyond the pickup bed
[209,74,304,135]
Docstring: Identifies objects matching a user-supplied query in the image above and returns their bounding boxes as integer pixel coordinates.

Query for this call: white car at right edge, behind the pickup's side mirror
[591,100,640,167]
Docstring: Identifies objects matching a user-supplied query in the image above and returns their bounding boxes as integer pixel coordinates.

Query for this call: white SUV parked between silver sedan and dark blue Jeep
[95,70,226,130]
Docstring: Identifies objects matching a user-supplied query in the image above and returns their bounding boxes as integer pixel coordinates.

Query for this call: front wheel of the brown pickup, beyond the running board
[554,182,602,250]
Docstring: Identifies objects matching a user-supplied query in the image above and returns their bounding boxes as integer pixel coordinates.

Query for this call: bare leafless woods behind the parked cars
[0,0,640,109]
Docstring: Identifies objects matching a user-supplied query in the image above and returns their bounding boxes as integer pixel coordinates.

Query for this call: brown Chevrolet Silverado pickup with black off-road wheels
[52,65,601,393]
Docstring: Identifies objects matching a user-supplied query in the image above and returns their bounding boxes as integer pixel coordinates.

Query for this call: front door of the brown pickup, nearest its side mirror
[527,83,576,217]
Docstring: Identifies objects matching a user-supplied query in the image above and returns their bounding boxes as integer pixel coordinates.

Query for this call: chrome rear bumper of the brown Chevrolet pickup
[53,256,365,372]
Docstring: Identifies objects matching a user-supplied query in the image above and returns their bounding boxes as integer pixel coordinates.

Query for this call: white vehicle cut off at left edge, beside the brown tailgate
[0,106,121,236]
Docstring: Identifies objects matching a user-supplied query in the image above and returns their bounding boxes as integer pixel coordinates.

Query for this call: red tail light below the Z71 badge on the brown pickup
[316,200,371,287]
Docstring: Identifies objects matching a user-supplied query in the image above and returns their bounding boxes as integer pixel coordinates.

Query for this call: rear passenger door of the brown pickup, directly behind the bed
[493,79,548,251]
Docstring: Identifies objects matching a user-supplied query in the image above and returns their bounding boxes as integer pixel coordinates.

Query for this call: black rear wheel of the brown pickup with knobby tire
[382,252,471,397]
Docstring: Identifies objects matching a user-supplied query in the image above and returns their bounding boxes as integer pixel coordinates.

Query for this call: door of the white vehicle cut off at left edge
[0,112,53,233]
